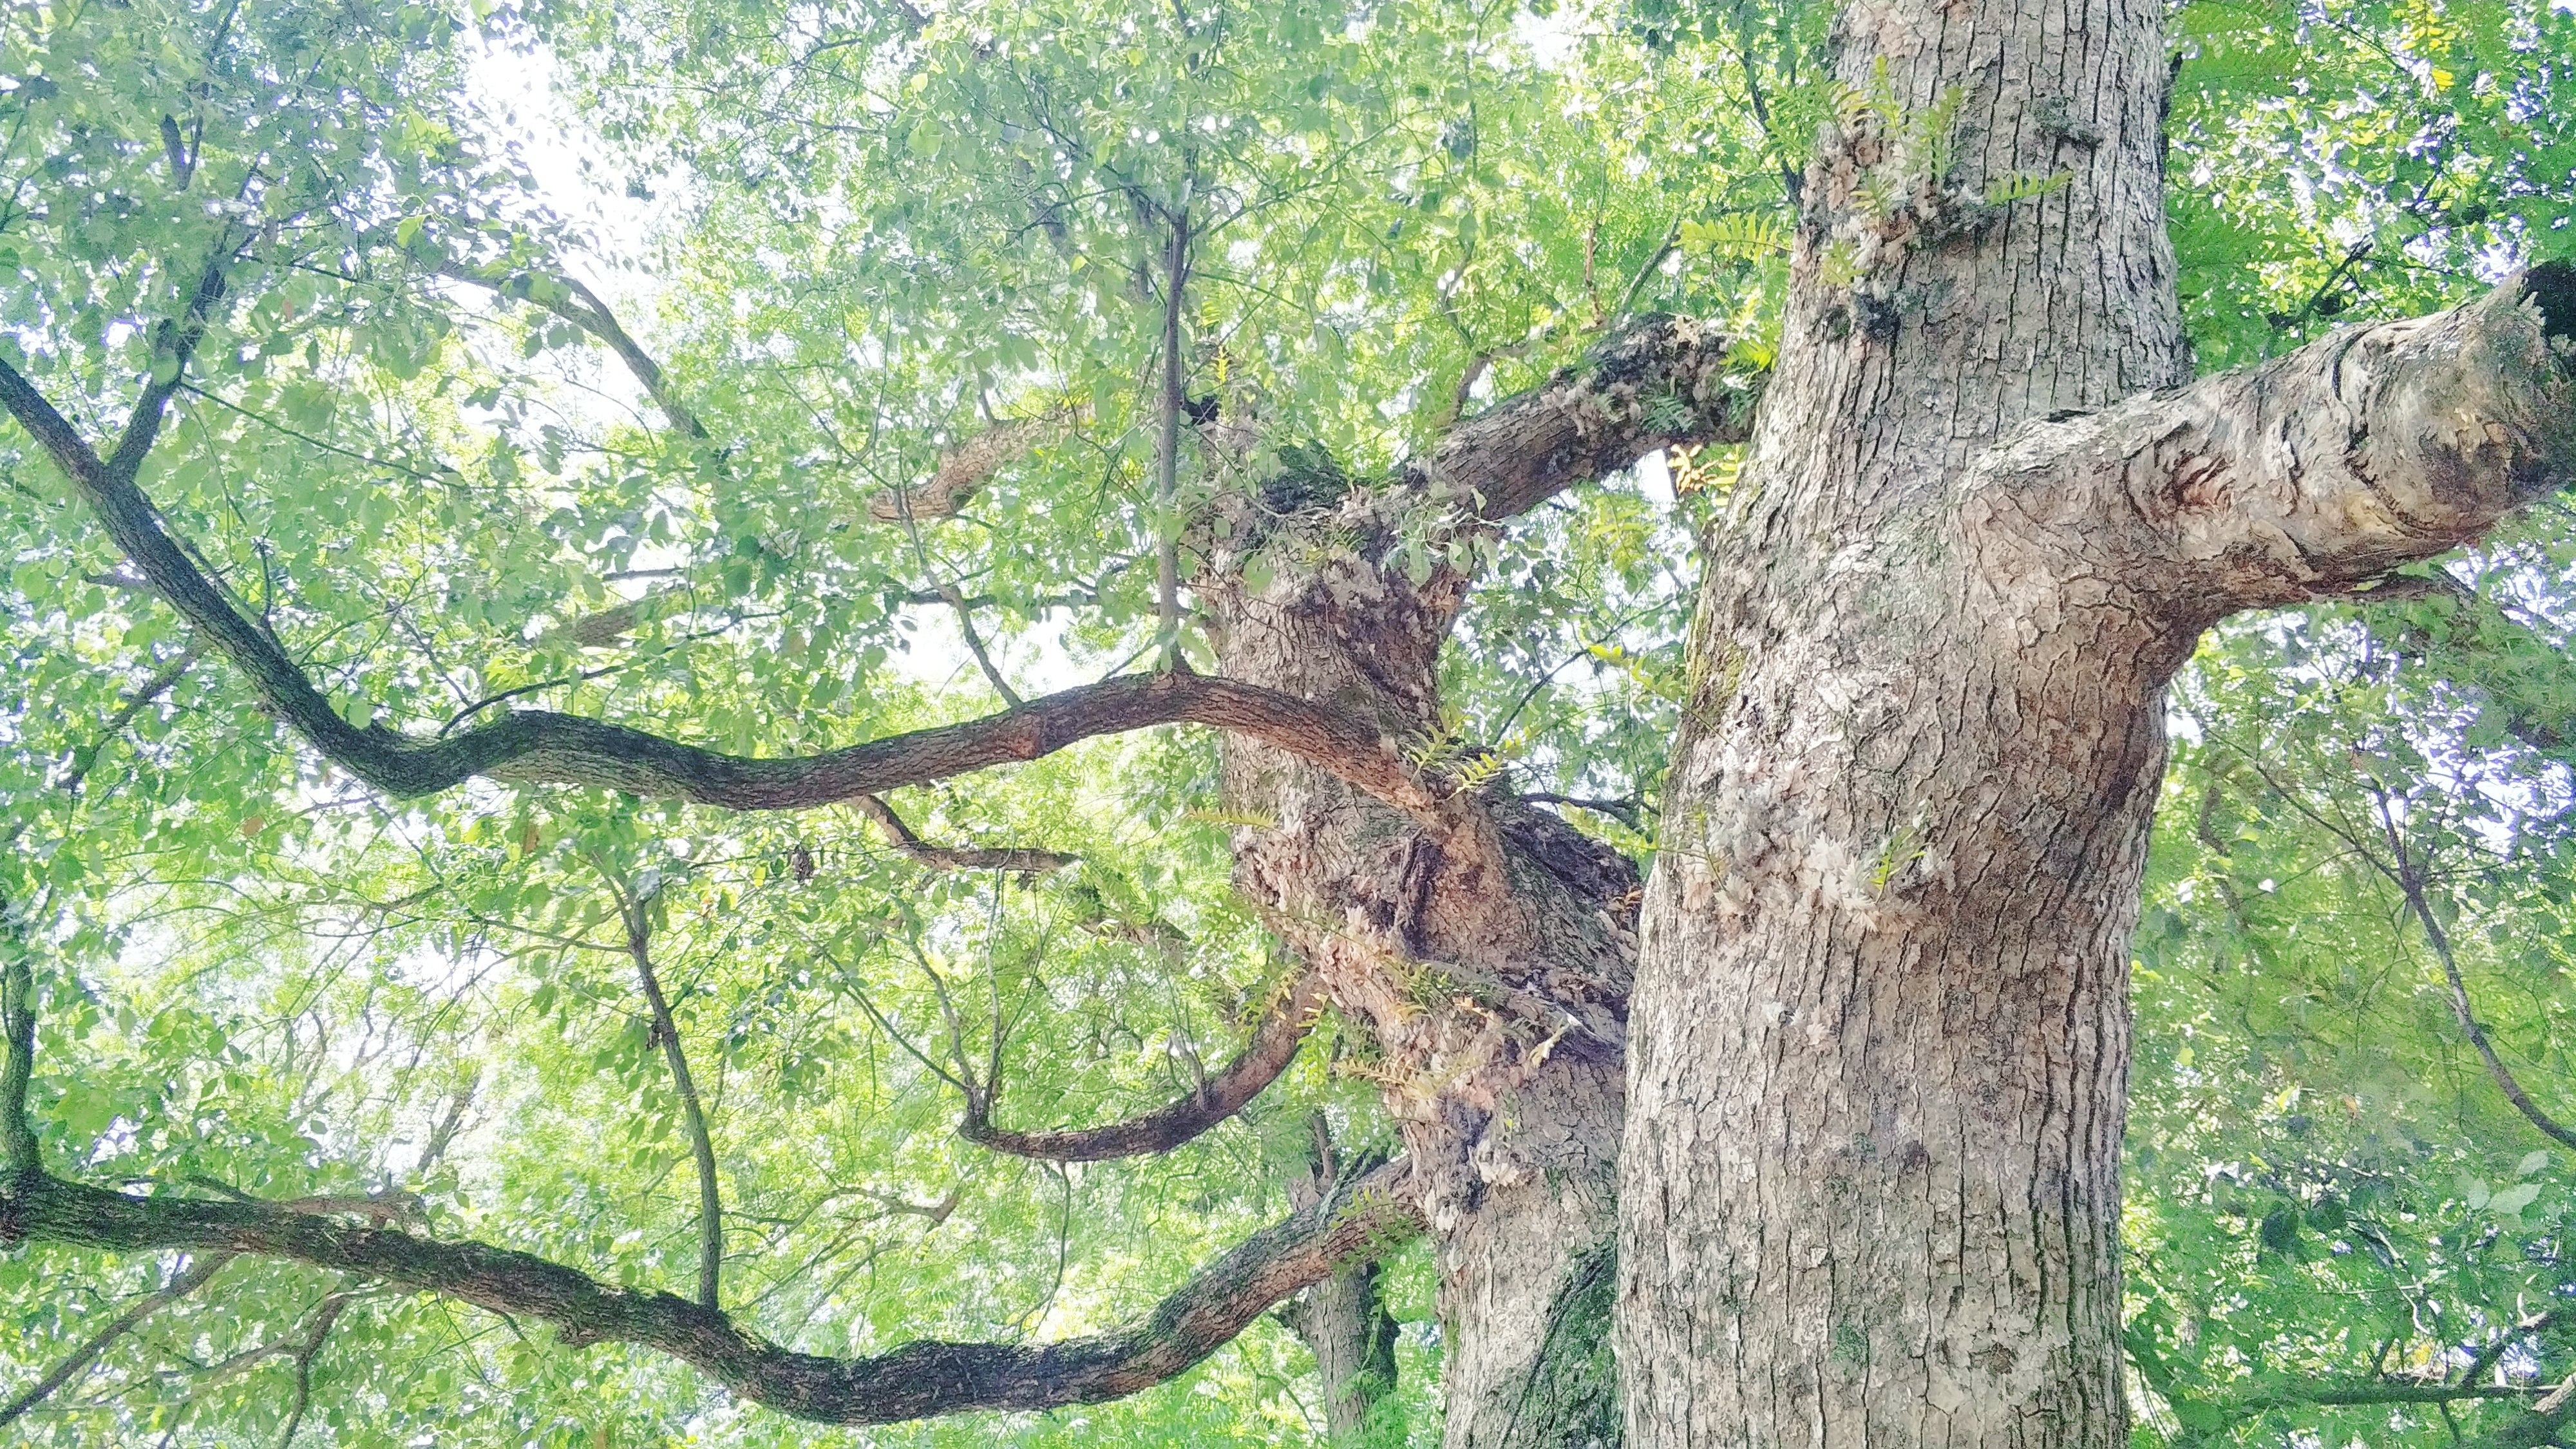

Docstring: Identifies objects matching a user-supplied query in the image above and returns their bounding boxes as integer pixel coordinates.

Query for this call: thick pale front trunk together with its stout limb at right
[1618,0,2576,1449]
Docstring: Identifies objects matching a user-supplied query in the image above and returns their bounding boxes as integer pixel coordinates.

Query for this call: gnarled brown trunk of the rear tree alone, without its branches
[1200,536,1636,1449]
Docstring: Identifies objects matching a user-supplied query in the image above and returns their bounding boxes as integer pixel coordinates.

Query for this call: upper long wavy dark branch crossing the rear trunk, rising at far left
[0,345,1437,815]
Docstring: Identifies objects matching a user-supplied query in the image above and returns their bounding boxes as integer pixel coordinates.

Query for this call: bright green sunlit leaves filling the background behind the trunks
[0,0,2576,1446]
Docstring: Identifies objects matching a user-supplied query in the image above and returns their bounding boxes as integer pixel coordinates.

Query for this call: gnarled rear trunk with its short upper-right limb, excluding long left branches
[1195,319,1759,1449]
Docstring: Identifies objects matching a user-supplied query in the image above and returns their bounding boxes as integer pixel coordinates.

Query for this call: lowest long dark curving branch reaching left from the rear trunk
[0,1163,1419,1423]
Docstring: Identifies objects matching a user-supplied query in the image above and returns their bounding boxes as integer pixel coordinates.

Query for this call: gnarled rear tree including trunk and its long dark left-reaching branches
[0,258,1762,1423]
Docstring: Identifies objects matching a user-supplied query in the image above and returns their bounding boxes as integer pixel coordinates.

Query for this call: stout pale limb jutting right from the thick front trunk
[1981,263,2576,611]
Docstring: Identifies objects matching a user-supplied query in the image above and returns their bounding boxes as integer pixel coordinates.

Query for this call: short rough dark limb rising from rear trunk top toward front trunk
[1422,314,1767,521]
